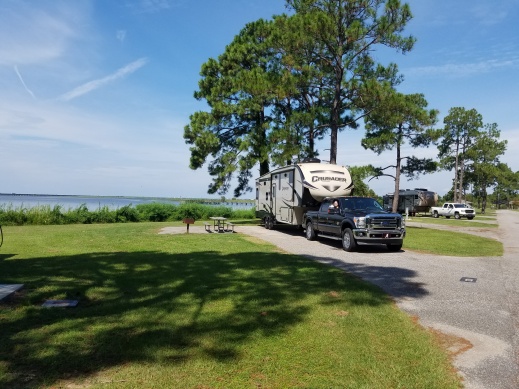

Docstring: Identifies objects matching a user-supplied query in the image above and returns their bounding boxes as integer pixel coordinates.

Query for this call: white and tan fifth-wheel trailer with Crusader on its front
[256,159,354,229]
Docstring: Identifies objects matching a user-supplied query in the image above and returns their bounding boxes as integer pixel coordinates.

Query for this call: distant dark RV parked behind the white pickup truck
[383,188,438,216]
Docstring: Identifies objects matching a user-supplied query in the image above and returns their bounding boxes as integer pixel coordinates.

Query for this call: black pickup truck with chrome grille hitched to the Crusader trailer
[303,197,405,251]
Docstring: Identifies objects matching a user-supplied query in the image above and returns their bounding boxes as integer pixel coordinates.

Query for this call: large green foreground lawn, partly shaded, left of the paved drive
[0,223,460,389]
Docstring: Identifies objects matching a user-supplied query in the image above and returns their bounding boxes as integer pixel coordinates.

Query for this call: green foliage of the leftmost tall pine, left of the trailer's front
[184,19,276,197]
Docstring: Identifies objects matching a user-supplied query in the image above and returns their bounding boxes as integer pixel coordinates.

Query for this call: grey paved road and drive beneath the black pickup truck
[239,210,519,389]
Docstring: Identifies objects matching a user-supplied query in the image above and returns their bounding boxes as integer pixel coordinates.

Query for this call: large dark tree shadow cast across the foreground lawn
[0,244,426,388]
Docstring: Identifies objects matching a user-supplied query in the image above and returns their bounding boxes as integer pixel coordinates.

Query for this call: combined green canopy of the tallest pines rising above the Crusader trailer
[184,0,415,197]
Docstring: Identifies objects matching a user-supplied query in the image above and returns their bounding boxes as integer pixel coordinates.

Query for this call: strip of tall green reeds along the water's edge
[0,202,255,226]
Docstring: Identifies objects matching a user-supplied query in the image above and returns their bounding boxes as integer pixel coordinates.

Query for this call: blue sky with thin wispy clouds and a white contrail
[0,0,519,198]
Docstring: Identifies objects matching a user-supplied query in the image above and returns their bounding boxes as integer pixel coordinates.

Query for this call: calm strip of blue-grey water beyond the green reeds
[0,194,254,211]
